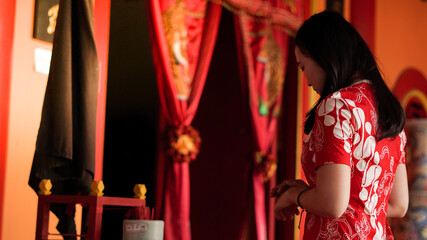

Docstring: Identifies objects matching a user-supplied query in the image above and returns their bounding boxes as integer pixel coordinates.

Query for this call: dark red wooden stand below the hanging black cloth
[36,195,145,240]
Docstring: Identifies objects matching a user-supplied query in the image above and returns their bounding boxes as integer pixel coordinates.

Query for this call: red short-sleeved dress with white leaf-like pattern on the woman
[301,80,406,240]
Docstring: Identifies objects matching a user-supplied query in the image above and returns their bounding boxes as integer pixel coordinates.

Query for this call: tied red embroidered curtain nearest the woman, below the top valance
[239,16,289,240]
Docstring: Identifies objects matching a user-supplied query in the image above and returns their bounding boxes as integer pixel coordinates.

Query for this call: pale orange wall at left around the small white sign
[1,0,51,240]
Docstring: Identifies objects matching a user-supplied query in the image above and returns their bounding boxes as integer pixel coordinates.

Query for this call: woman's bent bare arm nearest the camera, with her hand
[275,164,351,220]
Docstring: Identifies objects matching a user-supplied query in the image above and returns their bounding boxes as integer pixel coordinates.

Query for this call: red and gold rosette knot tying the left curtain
[168,125,202,162]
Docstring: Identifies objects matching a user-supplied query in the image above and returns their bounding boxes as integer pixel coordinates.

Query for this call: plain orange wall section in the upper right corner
[375,0,427,87]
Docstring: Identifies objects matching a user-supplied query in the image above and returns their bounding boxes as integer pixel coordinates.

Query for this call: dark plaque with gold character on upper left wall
[33,0,59,42]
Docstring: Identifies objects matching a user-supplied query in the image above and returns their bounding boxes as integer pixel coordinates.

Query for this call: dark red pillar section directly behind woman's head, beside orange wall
[350,0,375,53]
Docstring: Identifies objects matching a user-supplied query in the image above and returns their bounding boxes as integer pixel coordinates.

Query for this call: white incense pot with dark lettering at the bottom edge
[123,219,165,240]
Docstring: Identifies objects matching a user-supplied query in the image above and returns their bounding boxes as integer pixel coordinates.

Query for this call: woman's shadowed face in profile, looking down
[295,47,326,95]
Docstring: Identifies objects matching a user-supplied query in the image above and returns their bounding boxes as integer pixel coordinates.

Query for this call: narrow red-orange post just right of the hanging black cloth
[94,0,111,180]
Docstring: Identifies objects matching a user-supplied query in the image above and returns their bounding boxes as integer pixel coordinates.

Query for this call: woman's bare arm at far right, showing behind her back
[387,164,409,217]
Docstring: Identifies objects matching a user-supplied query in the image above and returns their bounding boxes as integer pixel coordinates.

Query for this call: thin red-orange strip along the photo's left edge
[0,0,15,237]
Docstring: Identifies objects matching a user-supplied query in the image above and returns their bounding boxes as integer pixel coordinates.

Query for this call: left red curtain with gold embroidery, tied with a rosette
[148,0,221,240]
